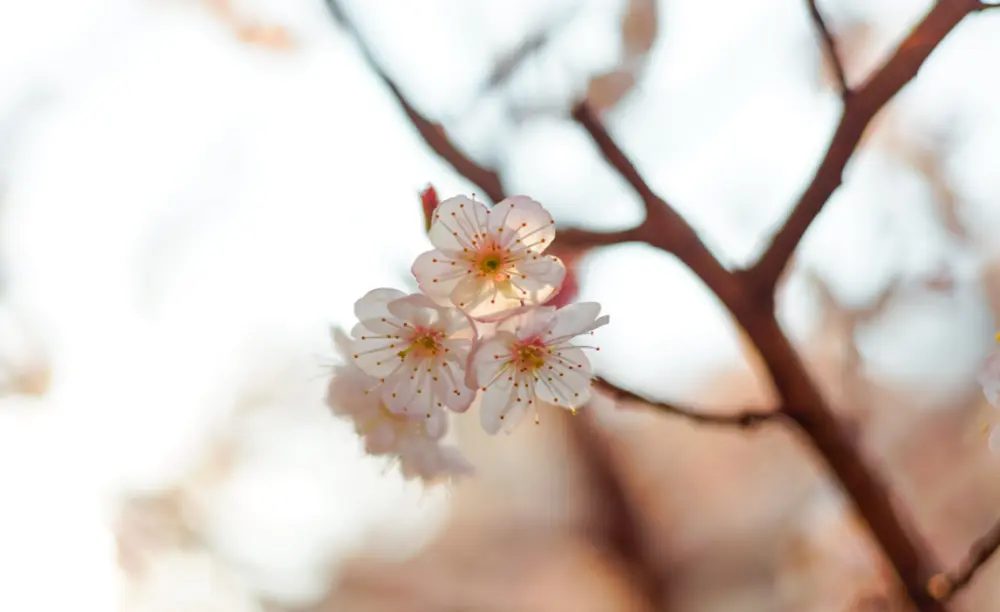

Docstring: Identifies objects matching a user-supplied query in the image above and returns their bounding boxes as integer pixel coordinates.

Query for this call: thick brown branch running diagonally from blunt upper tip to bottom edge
[574,97,945,612]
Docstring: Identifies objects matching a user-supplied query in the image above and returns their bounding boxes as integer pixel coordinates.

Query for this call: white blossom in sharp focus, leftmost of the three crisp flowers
[350,289,476,418]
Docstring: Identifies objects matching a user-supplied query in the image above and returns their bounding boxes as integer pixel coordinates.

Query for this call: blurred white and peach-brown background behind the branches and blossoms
[0,0,1000,612]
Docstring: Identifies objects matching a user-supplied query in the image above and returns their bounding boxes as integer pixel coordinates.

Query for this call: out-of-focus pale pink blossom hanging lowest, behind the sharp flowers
[326,329,472,482]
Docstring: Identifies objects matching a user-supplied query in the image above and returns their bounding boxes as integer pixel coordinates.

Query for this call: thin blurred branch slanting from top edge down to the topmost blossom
[326,0,505,202]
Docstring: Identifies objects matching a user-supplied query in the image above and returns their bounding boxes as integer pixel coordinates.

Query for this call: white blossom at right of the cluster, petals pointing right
[467,302,608,434]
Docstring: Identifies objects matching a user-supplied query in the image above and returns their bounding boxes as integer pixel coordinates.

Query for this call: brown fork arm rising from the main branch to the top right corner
[750,0,983,292]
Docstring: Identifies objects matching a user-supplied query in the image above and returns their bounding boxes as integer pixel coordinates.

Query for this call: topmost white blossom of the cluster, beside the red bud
[413,196,566,319]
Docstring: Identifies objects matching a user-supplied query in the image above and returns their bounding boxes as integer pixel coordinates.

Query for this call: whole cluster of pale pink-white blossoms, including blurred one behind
[328,196,608,481]
